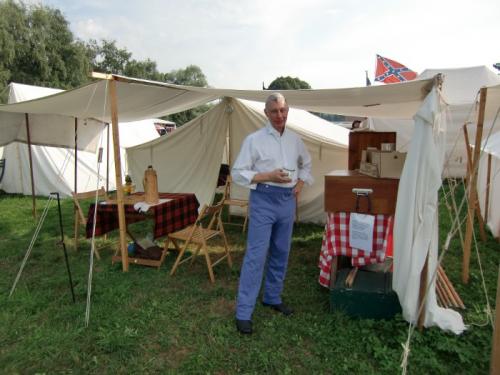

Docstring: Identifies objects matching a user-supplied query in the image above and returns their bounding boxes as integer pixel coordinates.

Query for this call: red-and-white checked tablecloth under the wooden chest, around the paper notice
[319,212,392,288]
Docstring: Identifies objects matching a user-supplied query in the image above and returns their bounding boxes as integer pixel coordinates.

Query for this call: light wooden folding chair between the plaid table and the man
[165,202,233,283]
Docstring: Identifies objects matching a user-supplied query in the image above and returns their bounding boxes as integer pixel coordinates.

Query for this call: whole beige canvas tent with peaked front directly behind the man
[127,98,349,223]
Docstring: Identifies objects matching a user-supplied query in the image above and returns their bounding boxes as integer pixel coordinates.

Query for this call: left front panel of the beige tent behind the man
[126,101,228,210]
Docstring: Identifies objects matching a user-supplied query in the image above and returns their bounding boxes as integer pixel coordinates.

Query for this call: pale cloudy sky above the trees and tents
[36,0,500,90]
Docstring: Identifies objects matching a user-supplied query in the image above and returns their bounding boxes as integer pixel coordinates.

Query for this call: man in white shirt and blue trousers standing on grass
[231,93,313,334]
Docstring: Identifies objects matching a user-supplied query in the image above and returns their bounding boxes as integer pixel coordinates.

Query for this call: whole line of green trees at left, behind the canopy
[0,0,210,125]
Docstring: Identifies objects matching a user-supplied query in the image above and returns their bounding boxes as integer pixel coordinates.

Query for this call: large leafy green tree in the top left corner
[0,0,89,102]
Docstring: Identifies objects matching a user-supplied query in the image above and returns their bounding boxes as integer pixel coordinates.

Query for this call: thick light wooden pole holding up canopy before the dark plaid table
[109,78,128,272]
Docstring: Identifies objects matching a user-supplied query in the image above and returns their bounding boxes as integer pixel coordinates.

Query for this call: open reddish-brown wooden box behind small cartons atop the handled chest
[347,132,396,170]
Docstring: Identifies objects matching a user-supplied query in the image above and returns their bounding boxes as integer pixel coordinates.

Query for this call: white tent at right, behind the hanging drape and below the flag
[367,66,500,177]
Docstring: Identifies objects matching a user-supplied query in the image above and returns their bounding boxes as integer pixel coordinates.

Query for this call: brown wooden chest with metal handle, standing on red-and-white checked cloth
[325,170,399,215]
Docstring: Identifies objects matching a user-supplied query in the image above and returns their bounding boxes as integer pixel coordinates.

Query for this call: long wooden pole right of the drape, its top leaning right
[462,87,487,284]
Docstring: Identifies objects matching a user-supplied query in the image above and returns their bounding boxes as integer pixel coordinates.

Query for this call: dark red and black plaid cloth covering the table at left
[86,193,200,238]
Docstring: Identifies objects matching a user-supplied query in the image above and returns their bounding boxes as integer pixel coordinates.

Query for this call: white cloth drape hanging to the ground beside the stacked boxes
[393,90,465,334]
